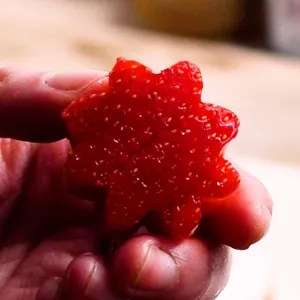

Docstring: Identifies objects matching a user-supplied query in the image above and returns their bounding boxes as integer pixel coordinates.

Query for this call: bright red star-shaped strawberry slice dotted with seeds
[62,58,240,239]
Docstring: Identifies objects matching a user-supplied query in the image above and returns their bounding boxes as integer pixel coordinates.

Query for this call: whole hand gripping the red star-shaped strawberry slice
[0,68,272,300]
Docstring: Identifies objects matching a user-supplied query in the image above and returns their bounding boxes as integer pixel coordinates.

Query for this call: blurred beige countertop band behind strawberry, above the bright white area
[0,0,300,164]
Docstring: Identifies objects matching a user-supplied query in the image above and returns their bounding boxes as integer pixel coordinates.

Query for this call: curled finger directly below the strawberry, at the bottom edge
[112,235,230,300]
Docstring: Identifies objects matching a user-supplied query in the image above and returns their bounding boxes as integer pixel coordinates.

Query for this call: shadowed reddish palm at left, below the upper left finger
[0,139,95,300]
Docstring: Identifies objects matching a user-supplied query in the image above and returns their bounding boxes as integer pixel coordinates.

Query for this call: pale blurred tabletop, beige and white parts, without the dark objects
[0,0,300,300]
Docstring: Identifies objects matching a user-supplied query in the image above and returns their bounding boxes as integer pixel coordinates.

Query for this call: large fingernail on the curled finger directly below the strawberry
[131,245,178,296]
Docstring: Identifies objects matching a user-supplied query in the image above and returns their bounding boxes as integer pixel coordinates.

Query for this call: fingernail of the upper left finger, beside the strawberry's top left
[45,71,107,92]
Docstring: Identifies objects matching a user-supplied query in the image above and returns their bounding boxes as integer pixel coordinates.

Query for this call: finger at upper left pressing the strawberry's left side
[0,67,106,142]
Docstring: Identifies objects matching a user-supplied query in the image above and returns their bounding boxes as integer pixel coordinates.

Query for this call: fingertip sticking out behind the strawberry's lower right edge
[200,168,273,249]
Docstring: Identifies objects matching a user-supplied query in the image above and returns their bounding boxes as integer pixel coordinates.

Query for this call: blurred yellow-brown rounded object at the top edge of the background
[134,0,244,38]
